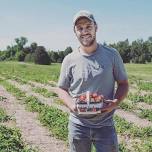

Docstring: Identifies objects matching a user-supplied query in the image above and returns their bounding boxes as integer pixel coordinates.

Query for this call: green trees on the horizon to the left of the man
[0,37,72,65]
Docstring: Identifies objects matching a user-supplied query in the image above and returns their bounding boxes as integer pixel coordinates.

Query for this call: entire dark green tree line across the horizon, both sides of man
[0,37,152,65]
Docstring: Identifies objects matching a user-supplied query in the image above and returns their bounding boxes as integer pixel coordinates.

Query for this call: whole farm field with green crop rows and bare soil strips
[0,62,152,152]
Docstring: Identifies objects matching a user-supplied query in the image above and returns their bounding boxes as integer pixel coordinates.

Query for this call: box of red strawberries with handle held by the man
[76,91,104,114]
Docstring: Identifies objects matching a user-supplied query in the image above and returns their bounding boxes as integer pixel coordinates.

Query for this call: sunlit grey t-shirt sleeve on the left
[57,57,70,90]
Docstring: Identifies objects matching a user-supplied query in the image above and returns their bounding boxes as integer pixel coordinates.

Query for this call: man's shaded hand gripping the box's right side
[101,99,118,112]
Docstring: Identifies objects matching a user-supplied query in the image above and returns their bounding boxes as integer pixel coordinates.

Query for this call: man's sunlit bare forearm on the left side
[56,87,76,112]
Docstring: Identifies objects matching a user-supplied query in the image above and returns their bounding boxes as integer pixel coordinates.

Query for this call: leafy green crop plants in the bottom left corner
[0,105,37,152]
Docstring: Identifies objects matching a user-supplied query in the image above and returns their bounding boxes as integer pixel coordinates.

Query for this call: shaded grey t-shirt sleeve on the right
[113,50,128,81]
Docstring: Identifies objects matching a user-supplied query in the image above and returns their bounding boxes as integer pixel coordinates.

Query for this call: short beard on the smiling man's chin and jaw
[78,35,96,47]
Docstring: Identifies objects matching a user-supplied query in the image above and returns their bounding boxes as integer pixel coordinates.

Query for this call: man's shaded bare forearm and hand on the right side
[101,80,129,112]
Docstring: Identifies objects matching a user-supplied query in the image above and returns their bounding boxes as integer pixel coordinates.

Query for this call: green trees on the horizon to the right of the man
[109,37,152,63]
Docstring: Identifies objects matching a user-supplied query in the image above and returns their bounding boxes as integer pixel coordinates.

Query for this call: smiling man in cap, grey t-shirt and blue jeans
[58,11,128,152]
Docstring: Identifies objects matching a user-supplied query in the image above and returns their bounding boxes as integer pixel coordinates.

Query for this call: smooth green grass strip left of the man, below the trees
[0,62,60,83]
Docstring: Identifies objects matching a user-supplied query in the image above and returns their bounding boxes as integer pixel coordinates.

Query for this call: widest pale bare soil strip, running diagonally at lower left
[0,86,68,152]
